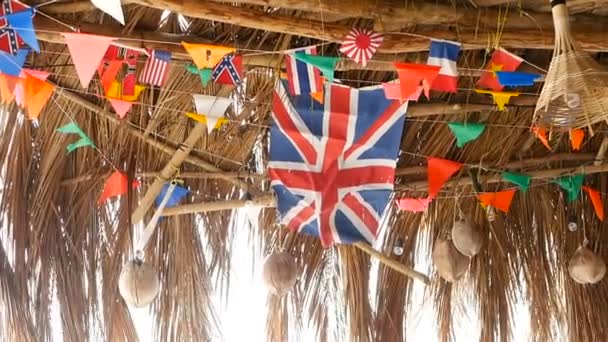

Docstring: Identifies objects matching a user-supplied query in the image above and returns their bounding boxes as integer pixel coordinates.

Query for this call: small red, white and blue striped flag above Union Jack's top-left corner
[285,46,323,96]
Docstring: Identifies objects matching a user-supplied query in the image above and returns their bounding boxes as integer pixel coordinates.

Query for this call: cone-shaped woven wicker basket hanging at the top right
[534,0,608,131]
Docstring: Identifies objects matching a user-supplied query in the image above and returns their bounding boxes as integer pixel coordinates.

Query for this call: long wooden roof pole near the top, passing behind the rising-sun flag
[129,0,608,53]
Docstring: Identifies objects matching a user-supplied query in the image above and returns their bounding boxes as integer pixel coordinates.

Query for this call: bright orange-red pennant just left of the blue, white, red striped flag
[393,62,441,99]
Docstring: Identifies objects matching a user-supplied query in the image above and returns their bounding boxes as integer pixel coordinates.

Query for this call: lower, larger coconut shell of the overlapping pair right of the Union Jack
[433,238,470,282]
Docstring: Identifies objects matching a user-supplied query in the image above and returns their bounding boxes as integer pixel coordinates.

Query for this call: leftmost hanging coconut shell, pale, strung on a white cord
[118,260,160,308]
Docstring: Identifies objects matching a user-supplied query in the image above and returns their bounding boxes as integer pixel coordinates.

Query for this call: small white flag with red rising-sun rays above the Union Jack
[340,28,384,66]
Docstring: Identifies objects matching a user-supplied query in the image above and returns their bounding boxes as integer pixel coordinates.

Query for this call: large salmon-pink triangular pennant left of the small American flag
[62,33,114,88]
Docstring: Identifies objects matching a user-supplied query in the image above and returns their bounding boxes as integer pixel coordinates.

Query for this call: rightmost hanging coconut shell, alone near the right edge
[568,246,606,284]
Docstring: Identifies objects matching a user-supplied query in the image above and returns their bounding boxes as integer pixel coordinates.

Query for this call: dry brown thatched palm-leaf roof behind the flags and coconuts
[0,0,608,341]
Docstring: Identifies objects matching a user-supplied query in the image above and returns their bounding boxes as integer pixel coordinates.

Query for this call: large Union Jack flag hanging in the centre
[268,82,407,247]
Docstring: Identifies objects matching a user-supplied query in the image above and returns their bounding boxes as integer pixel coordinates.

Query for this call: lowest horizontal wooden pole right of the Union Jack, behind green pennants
[395,164,608,191]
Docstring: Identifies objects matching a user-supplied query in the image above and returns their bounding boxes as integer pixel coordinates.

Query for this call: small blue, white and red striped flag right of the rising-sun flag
[426,39,460,93]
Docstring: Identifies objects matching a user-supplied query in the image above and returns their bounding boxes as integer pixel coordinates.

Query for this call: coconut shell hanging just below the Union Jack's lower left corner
[262,252,298,297]
